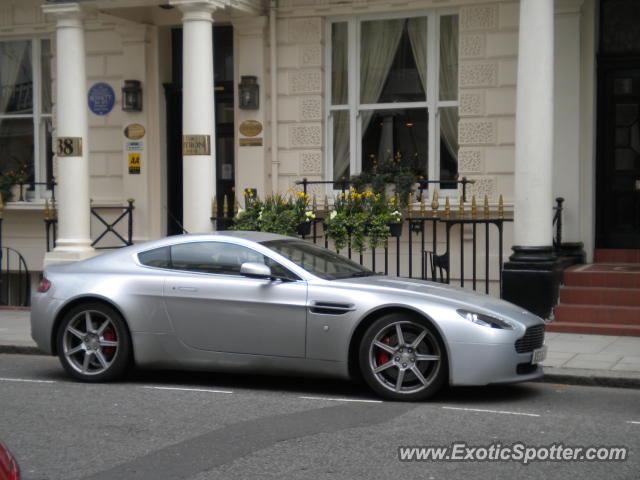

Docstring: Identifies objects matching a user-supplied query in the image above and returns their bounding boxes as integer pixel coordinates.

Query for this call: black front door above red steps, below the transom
[596,62,640,248]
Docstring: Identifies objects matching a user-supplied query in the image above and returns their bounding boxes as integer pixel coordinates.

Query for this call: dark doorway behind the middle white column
[164,26,235,235]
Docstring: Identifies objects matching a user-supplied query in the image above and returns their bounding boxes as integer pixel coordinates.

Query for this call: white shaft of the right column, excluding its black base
[514,0,556,247]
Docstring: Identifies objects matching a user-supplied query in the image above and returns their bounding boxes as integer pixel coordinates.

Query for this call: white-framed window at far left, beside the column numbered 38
[0,38,53,201]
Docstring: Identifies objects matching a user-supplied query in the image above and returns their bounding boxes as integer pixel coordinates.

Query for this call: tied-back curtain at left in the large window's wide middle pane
[360,18,406,161]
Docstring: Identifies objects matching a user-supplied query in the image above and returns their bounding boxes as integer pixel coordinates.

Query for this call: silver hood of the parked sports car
[330,275,543,326]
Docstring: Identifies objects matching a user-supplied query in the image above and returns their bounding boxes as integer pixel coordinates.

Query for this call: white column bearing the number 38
[43,3,95,265]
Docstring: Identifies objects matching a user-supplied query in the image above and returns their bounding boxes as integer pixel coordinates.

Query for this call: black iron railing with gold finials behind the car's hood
[308,198,513,293]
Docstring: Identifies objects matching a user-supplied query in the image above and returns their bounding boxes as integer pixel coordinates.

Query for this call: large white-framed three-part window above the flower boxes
[326,12,458,188]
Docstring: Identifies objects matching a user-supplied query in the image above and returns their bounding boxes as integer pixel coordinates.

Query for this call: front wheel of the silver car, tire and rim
[358,313,449,401]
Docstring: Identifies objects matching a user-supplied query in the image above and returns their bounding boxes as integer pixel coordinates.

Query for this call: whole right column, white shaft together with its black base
[502,0,560,318]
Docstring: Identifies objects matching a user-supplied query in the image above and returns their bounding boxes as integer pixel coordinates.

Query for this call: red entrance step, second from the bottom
[554,304,640,327]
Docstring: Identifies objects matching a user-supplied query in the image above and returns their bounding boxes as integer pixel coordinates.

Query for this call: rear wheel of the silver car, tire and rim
[57,303,131,382]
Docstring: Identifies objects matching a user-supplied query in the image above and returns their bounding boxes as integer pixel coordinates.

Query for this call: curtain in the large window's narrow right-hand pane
[439,15,458,159]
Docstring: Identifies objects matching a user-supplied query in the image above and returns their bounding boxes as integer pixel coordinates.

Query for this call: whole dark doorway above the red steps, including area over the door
[596,0,640,249]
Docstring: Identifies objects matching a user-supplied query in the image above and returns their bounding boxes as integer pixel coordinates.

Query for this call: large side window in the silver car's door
[170,242,297,280]
